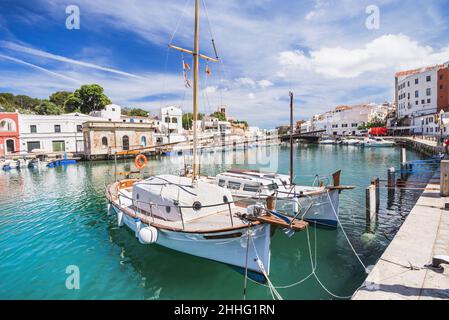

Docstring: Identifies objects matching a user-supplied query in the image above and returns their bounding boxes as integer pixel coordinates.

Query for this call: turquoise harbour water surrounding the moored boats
[0,145,430,299]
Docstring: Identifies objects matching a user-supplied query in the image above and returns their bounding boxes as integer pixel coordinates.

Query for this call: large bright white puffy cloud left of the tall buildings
[279,34,449,78]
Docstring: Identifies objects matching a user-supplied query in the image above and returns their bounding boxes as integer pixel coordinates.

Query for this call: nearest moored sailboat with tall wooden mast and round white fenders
[106,0,307,282]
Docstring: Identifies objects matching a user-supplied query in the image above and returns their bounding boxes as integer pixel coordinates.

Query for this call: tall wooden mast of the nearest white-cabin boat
[192,0,199,181]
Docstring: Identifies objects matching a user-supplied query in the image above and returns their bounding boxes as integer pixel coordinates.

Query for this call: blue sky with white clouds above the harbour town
[0,0,449,128]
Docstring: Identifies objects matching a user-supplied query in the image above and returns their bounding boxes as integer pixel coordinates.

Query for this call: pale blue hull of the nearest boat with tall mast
[113,206,270,278]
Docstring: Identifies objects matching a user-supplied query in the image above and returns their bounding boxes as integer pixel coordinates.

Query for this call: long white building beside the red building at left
[19,113,98,153]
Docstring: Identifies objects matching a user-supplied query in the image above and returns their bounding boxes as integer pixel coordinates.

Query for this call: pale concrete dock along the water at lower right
[352,172,449,300]
